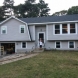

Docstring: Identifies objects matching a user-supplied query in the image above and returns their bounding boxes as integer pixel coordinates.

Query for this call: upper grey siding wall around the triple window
[46,23,78,40]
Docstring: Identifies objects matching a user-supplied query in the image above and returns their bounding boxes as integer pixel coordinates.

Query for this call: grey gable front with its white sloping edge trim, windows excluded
[0,18,31,41]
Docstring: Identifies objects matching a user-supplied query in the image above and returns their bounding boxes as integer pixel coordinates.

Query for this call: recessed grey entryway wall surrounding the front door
[35,26,46,48]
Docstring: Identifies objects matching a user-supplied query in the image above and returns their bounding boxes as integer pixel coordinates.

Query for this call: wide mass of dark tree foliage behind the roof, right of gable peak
[14,0,50,18]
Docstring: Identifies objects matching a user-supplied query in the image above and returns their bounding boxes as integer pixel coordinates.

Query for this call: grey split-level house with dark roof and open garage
[0,14,78,54]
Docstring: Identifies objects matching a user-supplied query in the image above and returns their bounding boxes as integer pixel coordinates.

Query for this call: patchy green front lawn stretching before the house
[0,51,78,78]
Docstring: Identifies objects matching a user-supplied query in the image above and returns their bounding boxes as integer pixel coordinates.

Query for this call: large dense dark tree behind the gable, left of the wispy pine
[14,0,39,18]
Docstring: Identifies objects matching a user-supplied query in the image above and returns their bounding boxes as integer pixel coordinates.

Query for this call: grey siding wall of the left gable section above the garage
[0,19,30,41]
